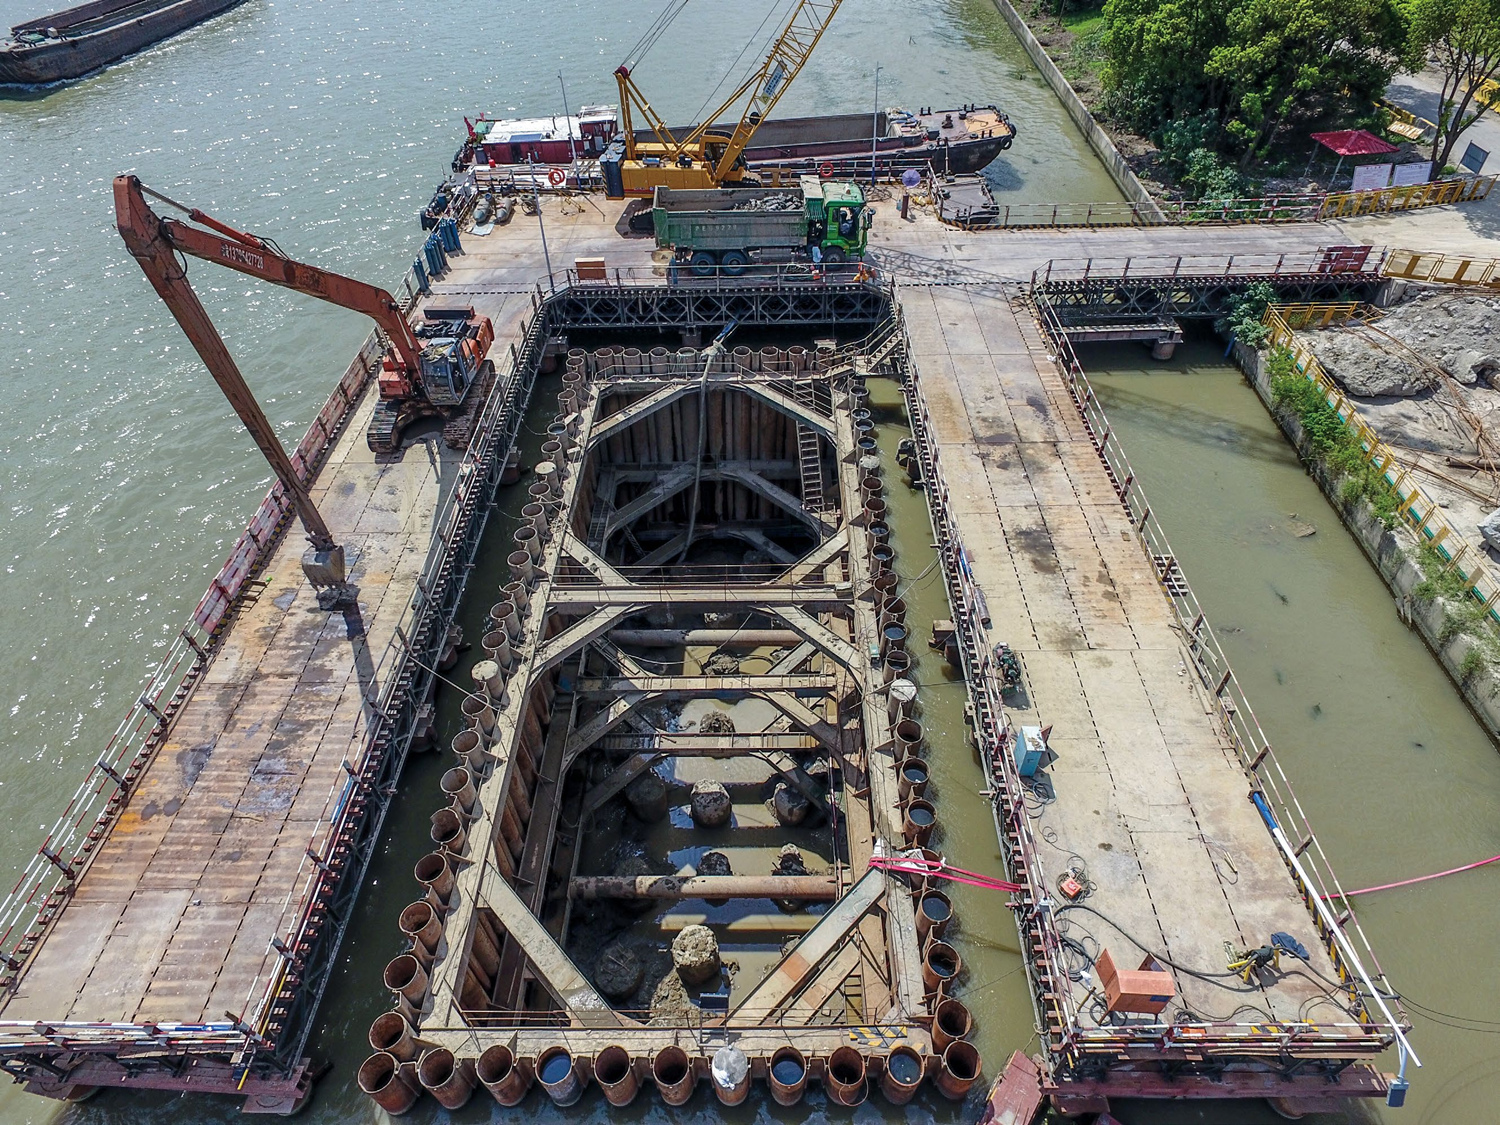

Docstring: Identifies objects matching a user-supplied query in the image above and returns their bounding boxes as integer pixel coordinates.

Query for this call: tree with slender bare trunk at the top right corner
[1404,0,1500,170]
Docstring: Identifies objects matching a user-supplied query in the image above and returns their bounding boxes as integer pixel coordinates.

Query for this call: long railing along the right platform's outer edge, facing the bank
[1035,292,1407,1049]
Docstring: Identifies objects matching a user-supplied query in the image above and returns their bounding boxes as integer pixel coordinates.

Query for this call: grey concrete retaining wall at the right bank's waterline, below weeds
[1235,344,1500,741]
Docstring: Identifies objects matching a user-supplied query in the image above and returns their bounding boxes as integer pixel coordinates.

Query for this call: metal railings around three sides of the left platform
[0,226,546,1053]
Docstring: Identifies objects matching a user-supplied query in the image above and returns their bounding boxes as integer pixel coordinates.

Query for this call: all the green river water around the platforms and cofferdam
[0,0,1500,1125]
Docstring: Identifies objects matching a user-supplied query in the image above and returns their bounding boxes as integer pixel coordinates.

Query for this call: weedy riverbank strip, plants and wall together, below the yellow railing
[1235,344,1500,741]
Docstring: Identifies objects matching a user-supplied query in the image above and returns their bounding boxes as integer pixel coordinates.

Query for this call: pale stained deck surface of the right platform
[900,287,1347,1026]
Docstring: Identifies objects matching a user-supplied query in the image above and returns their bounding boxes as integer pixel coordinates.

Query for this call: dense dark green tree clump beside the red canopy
[1104,0,1404,164]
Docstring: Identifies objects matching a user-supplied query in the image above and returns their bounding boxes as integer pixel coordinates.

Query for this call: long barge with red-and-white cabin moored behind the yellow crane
[453,105,1016,176]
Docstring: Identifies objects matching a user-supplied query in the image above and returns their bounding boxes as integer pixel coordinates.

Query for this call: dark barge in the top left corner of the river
[0,0,245,86]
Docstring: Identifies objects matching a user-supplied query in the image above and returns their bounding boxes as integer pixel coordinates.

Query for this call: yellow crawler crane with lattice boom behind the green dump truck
[606,0,843,195]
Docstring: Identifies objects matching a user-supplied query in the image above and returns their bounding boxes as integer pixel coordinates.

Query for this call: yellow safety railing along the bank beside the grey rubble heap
[1263,305,1500,621]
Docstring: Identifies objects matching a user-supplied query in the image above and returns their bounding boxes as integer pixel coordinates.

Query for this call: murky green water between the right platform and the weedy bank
[1080,344,1500,1125]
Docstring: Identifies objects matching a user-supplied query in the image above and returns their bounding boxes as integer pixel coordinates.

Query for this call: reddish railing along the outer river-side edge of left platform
[0,333,381,989]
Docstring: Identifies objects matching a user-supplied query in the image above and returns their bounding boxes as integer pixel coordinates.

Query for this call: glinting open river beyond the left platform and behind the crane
[0,0,1119,1122]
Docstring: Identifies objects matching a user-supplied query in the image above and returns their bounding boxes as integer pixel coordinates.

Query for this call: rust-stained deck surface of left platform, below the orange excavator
[0,363,486,1023]
